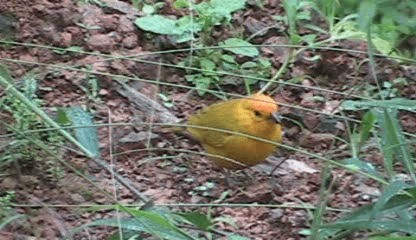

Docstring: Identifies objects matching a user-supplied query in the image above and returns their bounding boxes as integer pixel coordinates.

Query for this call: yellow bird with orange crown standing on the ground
[187,94,282,170]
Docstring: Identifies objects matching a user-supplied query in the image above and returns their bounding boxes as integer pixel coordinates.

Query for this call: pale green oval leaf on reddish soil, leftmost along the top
[134,15,184,35]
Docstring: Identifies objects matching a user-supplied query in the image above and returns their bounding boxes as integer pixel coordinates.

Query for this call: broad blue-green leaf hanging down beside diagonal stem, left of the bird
[66,106,100,157]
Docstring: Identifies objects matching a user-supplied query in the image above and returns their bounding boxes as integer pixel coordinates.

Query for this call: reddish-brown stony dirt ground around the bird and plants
[0,0,416,240]
